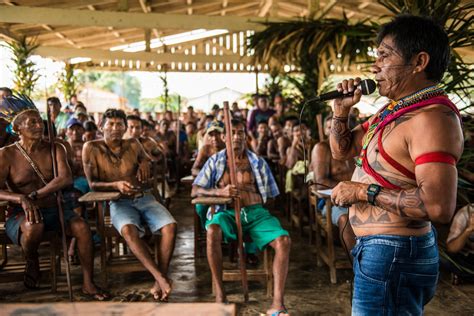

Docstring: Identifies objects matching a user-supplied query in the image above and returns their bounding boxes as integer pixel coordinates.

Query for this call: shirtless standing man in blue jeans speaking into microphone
[330,15,463,315]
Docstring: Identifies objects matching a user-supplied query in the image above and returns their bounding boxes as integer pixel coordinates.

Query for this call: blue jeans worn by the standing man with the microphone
[352,228,439,316]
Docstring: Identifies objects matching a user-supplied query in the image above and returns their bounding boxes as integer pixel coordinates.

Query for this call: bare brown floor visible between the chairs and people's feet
[0,192,474,315]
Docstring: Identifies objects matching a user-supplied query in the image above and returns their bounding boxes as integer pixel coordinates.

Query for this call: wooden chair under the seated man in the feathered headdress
[0,201,61,293]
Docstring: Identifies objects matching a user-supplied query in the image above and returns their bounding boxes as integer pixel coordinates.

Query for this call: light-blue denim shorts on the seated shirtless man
[110,192,176,237]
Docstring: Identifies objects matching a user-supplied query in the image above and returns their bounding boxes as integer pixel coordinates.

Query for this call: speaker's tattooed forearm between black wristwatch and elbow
[375,188,429,220]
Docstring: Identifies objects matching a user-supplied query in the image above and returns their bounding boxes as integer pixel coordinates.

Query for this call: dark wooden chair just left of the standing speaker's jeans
[309,186,352,284]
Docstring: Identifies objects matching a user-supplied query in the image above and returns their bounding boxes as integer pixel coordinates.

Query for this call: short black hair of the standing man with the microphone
[377,14,450,82]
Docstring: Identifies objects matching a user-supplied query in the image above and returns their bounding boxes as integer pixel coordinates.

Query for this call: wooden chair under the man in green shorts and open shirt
[191,197,273,297]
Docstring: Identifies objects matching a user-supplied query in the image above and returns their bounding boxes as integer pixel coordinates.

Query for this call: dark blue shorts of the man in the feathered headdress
[5,199,78,245]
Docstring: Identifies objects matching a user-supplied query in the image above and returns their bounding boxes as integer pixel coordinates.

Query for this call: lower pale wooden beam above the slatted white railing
[35,46,251,65]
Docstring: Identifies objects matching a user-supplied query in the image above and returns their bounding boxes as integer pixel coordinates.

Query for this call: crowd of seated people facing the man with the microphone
[0,88,474,311]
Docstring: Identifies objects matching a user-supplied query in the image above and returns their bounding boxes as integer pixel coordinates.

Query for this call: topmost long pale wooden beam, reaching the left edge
[0,6,283,31]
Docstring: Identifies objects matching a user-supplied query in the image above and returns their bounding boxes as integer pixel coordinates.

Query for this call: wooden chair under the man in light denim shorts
[79,192,158,286]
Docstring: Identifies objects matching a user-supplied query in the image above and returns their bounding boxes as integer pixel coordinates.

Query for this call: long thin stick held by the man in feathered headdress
[46,107,73,302]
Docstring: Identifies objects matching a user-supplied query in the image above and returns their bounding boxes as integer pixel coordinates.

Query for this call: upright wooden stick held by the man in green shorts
[224,101,249,302]
